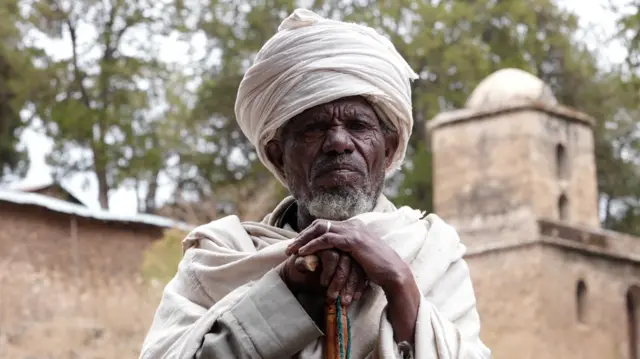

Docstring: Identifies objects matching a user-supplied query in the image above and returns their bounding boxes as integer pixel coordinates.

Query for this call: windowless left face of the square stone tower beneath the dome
[432,112,534,225]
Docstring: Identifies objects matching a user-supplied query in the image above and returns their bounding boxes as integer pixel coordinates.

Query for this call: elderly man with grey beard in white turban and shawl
[141,10,490,359]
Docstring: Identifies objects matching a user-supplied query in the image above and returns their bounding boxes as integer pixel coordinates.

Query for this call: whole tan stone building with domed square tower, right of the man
[428,69,640,359]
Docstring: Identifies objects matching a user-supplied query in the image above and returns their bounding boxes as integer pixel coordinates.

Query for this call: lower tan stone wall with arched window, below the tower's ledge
[465,242,640,359]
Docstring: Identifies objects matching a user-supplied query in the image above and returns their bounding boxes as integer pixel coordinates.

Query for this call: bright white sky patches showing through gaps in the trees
[13,0,625,214]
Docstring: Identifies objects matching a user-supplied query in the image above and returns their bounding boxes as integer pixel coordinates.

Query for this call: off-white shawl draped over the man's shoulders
[140,197,490,359]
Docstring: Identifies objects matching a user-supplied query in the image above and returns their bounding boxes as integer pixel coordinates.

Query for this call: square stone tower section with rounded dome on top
[428,69,599,250]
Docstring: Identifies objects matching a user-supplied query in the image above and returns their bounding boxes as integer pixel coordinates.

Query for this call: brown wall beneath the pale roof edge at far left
[0,203,162,277]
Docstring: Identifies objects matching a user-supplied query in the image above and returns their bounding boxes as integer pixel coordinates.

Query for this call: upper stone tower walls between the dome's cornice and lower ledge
[432,110,599,235]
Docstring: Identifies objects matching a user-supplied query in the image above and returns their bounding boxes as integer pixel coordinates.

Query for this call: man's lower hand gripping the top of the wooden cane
[278,250,367,305]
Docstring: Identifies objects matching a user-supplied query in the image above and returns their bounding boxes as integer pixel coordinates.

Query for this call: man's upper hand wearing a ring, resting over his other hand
[287,220,413,298]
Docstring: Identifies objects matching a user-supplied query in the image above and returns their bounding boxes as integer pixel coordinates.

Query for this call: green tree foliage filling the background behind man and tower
[0,0,640,234]
